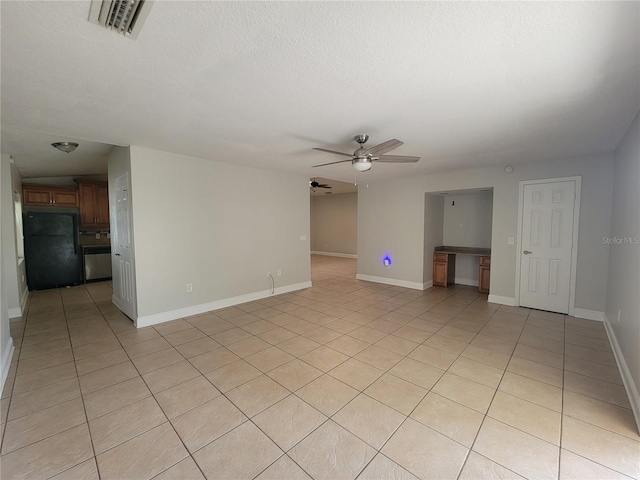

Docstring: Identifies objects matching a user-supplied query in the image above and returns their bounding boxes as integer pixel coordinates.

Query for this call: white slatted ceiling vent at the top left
[89,0,153,39]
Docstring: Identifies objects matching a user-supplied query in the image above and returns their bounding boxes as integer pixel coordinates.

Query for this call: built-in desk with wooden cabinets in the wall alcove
[433,245,491,293]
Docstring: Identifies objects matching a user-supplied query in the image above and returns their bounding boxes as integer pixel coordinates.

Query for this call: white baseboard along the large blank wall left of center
[135,281,311,328]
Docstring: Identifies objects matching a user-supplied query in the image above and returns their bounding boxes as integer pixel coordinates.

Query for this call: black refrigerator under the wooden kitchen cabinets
[23,212,83,290]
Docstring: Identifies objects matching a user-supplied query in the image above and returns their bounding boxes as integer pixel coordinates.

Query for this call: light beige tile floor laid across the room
[0,257,640,480]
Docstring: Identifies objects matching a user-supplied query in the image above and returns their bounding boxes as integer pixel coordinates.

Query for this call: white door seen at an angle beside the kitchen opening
[113,172,136,320]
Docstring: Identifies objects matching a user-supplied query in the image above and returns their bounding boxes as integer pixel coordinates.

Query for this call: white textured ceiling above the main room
[0,1,640,182]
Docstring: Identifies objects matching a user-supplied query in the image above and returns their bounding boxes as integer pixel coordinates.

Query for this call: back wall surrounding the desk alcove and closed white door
[358,155,613,312]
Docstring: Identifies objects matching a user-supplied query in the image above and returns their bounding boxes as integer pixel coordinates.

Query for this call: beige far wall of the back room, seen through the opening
[310,192,358,255]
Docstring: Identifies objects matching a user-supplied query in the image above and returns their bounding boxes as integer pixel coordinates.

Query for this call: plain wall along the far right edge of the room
[606,110,640,426]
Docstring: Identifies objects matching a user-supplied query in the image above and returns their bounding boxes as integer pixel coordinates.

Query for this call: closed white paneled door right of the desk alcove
[520,180,576,314]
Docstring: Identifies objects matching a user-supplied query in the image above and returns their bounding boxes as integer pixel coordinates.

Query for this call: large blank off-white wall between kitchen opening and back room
[130,146,311,324]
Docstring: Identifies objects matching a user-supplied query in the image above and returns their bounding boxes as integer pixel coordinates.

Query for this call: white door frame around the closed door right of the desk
[515,176,582,316]
